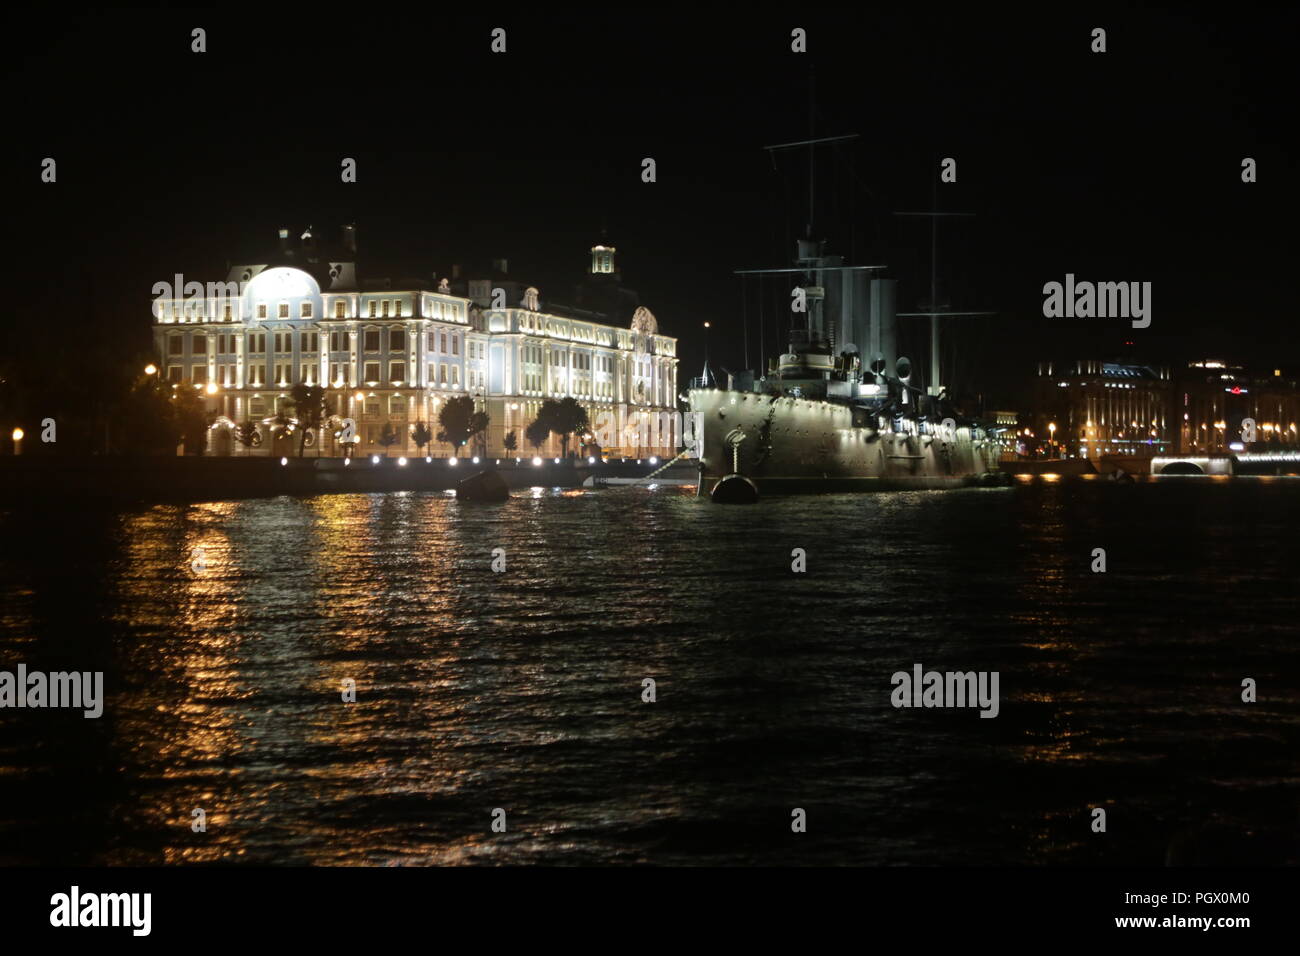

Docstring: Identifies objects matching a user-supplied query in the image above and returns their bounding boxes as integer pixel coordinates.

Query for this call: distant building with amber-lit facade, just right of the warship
[1031,359,1178,458]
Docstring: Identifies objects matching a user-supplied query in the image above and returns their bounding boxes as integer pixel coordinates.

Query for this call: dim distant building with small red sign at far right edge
[1177,359,1300,454]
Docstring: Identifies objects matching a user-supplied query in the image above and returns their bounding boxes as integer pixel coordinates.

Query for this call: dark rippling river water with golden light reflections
[0,479,1300,865]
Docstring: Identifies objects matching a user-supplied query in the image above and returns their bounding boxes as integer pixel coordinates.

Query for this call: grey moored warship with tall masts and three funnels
[686,137,1010,502]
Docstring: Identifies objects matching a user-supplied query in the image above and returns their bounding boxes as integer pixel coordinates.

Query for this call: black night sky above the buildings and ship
[4,4,1297,403]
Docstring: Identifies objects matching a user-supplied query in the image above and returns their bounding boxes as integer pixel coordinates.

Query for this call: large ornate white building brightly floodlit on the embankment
[153,226,680,457]
